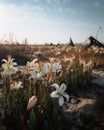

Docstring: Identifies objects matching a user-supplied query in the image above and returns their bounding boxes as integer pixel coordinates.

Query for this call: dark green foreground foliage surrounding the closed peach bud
[2,77,62,130]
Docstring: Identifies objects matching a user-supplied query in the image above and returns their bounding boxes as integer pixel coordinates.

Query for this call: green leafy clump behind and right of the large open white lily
[62,66,91,93]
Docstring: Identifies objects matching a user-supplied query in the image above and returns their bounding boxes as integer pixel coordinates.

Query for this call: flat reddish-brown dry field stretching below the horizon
[0,44,104,68]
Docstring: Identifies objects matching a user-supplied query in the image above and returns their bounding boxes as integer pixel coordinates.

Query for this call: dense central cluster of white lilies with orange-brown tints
[26,59,62,80]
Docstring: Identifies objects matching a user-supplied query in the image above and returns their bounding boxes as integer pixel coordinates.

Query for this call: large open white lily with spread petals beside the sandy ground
[51,83,69,106]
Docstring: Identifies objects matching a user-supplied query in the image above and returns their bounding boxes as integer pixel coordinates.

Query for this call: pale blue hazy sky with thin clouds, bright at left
[0,0,104,44]
